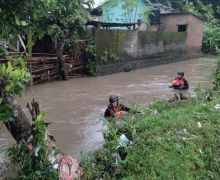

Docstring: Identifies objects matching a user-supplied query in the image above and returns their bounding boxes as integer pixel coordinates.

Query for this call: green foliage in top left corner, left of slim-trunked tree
[0,0,56,54]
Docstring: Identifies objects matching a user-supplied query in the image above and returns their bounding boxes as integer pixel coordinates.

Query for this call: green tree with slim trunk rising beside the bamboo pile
[39,0,92,80]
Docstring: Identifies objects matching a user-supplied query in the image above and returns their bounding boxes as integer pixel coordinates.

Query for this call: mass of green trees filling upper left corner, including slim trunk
[0,0,93,80]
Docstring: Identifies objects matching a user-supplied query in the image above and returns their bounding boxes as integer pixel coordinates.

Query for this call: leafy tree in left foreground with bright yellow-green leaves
[0,58,59,179]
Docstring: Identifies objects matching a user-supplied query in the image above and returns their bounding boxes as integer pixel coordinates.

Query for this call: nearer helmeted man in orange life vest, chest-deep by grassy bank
[105,94,130,117]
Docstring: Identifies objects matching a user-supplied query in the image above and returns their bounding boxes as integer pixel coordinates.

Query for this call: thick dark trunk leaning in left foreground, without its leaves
[4,94,31,142]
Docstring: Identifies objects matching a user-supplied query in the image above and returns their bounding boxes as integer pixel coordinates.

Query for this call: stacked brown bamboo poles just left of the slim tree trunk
[28,56,59,84]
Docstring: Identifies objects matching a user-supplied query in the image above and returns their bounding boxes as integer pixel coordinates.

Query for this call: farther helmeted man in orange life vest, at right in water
[170,72,189,90]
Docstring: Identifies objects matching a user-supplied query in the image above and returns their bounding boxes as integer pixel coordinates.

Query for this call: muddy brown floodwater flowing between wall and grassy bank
[0,57,216,162]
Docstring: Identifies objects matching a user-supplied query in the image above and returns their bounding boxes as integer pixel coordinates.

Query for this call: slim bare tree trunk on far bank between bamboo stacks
[56,40,69,80]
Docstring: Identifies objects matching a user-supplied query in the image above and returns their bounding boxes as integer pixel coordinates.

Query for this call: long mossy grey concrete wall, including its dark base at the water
[95,30,188,75]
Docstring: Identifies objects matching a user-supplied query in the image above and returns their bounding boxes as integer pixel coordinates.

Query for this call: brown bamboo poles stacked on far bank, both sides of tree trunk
[0,51,86,84]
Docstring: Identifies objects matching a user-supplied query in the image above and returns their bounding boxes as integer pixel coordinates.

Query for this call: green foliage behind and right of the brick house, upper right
[151,0,220,54]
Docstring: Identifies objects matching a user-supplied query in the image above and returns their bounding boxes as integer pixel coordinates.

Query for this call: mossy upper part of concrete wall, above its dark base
[95,30,186,61]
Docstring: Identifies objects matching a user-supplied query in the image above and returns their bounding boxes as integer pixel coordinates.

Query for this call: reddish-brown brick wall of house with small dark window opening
[160,14,204,53]
